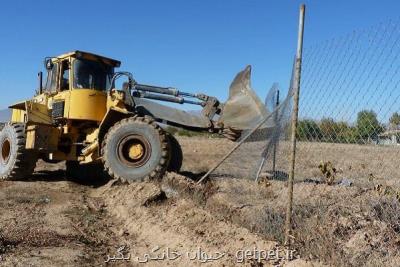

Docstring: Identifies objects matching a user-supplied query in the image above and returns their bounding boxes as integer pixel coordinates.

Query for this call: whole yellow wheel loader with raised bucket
[0,51,267,181]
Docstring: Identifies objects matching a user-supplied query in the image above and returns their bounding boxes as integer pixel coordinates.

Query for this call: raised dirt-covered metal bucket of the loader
[218,66,269,130]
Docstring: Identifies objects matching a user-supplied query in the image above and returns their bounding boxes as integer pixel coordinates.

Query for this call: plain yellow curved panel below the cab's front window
[65,89,107,122]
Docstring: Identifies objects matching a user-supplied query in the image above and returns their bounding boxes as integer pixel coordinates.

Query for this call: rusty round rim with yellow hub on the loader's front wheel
[117,135,151,168]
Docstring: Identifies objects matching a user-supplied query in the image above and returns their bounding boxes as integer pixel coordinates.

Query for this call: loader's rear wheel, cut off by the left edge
[0,123,38,180]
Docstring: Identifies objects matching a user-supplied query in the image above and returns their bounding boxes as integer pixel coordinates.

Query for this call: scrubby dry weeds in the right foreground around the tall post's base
[202,178,400,266]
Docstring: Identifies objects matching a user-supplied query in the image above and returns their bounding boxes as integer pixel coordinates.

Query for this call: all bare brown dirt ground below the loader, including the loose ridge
[0,160,318,266]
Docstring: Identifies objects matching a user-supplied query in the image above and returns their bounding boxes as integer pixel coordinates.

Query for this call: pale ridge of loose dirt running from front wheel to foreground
[94,176,282,266]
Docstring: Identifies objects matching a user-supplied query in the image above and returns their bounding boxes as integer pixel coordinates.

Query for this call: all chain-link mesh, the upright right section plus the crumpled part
[200,17,400,266]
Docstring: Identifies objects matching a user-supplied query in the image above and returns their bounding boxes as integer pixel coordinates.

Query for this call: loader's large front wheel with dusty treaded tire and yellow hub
[101,116,169,182]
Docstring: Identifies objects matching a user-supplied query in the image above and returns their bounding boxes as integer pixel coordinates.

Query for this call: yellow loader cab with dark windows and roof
[44,51,121,122]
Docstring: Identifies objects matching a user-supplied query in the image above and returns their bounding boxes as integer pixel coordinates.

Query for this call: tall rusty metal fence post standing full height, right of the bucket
[285,4,306,246]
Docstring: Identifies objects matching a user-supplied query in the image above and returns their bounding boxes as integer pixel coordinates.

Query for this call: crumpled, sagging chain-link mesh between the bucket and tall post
[212,75,293,181]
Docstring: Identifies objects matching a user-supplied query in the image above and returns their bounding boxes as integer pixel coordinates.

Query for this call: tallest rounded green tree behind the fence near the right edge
[357,110,383,142]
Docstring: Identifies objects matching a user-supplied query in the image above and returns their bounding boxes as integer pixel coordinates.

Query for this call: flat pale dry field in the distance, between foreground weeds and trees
[179,137,400,187]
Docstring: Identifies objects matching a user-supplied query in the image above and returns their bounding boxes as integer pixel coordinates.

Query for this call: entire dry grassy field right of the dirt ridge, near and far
[180,138,400,266]
